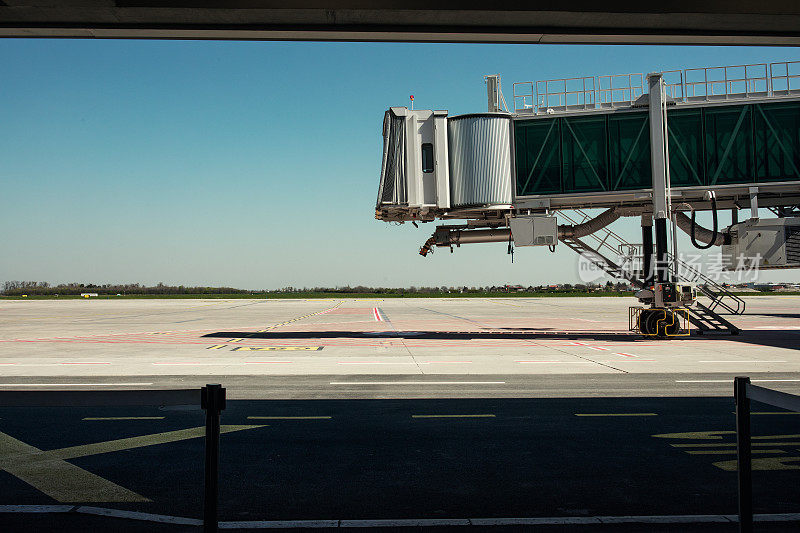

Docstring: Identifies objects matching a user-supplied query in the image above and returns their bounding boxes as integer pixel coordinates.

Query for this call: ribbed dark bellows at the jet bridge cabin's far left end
[377,111,408,208]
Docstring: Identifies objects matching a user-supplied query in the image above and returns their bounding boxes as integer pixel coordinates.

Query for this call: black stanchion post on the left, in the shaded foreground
[200,385,225,533]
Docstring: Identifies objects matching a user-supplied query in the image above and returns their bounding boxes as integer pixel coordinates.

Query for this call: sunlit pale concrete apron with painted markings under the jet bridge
[0,296,800,394]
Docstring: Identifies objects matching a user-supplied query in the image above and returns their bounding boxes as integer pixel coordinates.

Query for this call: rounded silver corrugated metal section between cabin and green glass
[447,114,511,207]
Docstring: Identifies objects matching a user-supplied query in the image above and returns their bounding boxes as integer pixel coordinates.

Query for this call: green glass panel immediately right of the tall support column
[664,108,706,187]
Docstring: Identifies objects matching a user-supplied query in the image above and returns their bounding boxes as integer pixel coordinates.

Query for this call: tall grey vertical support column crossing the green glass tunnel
[647,73,671,282]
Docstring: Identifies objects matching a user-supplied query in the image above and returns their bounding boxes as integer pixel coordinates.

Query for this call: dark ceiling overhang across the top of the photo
[0,0,800,45]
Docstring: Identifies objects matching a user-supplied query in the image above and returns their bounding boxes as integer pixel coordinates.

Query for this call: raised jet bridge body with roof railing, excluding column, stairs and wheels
[376,62,800,268]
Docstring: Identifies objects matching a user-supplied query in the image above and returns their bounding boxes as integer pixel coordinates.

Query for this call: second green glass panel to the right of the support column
[704,105,755,185]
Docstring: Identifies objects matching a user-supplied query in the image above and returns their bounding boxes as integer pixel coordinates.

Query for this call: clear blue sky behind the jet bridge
[0,39,800,288]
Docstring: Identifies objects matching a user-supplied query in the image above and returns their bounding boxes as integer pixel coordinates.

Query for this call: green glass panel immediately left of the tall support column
[608,112,653,191]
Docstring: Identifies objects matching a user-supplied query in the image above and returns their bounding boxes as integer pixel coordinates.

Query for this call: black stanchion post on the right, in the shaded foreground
[733,377,753,533]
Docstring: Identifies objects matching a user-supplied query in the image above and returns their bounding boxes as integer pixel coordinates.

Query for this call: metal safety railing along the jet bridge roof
[512,61,800,115]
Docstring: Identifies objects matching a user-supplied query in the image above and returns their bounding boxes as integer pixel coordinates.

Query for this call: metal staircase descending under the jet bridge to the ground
[559,209,745,335]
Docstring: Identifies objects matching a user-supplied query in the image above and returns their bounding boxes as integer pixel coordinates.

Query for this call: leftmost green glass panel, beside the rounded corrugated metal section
[514,118,561,196]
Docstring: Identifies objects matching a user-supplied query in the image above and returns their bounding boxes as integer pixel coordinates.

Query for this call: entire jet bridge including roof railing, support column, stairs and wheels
[375,61,800,338]
